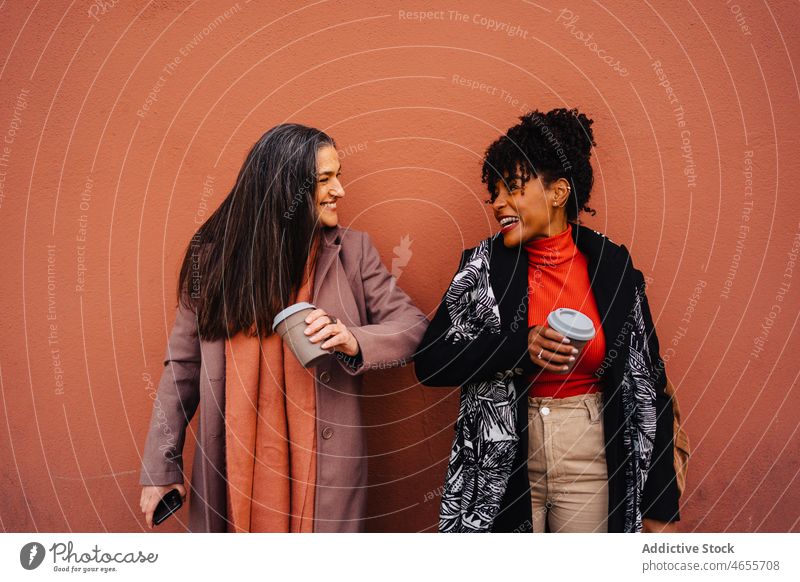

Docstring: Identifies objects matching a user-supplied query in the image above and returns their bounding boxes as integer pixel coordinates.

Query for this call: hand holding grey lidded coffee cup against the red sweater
[528,307,595,374]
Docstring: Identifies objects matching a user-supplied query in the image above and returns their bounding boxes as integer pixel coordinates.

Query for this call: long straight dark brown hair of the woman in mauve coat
[178,123,336,341]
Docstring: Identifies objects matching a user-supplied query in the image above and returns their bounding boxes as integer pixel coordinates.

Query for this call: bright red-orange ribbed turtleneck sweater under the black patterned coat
[525,223,606,398]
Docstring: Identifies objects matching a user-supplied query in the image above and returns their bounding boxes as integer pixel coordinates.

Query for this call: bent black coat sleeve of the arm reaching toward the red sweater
[414,249,540,386]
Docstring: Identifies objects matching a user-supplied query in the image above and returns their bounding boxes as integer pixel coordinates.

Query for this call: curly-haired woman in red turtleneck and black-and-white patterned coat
[415,109,680,532]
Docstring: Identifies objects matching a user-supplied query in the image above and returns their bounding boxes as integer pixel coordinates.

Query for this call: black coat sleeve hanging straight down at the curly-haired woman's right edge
[635,270,680,522]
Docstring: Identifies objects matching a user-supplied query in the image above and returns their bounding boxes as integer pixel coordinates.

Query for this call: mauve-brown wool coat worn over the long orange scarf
[140,227,428,532]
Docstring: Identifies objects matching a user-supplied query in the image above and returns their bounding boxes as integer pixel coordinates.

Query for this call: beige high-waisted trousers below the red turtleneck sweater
[528,392,608,533]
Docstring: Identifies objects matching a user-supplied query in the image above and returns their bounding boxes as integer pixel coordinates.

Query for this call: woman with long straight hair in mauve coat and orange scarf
[140,124,428,532]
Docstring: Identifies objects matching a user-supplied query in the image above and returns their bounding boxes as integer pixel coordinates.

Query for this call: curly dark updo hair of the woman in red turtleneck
[481,107,597,221]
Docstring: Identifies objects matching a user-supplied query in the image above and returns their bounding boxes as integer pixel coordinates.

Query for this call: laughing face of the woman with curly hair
[491,167,570,247]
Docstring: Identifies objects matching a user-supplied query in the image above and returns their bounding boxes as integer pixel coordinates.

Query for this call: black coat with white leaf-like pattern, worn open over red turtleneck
[414,223,679,532]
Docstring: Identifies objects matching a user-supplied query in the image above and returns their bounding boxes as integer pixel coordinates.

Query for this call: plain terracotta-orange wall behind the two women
[0,0,800,531]
